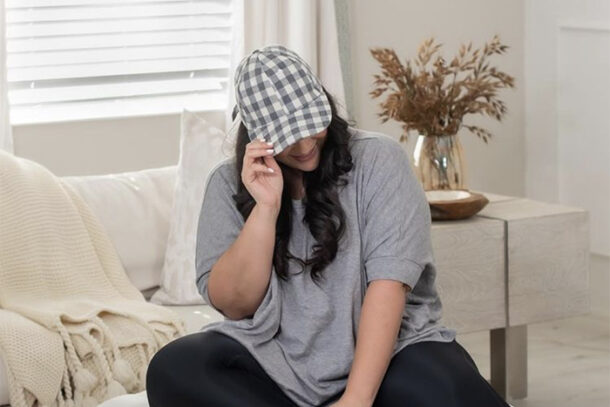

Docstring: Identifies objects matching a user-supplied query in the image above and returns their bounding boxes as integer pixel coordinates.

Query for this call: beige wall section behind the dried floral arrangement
[350,0,525,196]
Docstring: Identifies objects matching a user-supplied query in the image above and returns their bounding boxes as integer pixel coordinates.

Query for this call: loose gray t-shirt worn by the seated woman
[196,127,456,407]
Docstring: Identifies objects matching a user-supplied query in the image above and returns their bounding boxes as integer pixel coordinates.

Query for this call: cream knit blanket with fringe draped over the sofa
[0,150,186,407]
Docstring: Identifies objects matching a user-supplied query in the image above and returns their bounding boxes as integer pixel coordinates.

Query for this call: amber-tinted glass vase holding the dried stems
[413,134,467,191]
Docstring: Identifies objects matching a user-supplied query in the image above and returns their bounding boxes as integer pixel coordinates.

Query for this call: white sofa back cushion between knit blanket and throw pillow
[60,165,176,291]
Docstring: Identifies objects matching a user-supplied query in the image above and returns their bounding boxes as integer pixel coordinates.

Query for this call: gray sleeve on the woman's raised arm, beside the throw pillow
[195,164,244,312]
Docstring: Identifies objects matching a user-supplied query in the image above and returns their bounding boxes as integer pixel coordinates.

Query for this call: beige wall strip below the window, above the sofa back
[13,112,224,176]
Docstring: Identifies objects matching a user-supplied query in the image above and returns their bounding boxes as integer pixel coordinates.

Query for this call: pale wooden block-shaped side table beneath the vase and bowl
[432,191,590,399]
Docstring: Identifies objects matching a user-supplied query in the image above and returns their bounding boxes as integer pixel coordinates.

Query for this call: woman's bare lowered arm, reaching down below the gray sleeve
[332,279,410,407]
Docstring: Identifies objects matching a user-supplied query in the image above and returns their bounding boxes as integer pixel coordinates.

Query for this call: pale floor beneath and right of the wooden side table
[457,314,610,407]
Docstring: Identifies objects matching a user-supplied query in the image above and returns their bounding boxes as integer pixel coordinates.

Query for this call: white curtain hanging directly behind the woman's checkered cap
[225,0,350,135]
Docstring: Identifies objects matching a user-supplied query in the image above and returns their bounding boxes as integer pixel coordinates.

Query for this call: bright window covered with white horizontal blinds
[5,0,232,125]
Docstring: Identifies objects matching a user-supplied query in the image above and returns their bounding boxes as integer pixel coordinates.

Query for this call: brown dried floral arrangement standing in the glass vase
[369,35,514,143]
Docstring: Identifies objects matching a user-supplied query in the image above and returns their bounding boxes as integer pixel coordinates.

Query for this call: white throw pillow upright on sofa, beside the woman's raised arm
[150,109,234,305]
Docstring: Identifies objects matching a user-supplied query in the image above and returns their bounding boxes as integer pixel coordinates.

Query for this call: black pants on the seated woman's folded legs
[146,331,508,407]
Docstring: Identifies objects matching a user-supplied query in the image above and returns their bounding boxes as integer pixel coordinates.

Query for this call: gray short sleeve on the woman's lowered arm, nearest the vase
[363,135,434,289]
